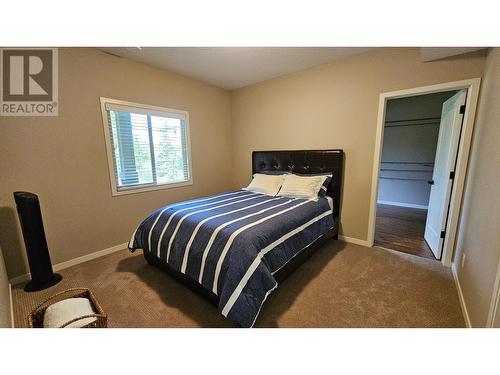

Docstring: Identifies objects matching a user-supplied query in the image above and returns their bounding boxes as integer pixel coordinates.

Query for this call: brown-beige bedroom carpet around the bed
[13,241,464,327]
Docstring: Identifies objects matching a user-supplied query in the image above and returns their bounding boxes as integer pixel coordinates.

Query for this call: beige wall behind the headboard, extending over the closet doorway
[231,48,484,240]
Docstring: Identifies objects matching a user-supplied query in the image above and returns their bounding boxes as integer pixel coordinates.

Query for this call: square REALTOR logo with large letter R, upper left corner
[0,48,58,116]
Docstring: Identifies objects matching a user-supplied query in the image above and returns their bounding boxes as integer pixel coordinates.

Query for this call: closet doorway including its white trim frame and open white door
[367,78,480,266]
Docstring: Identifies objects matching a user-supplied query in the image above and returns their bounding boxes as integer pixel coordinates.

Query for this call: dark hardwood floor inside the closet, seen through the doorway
[375,204,436,259]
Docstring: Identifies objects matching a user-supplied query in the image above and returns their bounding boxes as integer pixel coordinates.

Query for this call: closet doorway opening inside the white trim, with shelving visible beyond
[375,90,460,259]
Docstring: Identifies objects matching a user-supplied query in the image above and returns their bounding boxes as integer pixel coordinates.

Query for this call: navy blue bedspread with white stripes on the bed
[129,190,333,327]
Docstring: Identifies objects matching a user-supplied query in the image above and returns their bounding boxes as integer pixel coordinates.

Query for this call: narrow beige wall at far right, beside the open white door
[453,48,500,327]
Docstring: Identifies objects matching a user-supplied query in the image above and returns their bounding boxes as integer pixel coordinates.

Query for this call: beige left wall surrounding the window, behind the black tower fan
[0,48,232,278]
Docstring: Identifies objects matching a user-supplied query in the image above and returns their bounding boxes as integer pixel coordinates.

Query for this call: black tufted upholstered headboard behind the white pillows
[252,150,344,217]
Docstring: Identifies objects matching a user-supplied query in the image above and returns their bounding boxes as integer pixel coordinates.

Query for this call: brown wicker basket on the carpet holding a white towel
[28,288,108,328]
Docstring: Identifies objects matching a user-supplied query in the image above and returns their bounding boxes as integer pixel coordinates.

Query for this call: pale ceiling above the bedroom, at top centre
[101,47,370,90]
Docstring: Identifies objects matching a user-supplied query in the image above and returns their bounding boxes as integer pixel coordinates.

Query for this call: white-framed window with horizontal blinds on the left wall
[101,98,192,195]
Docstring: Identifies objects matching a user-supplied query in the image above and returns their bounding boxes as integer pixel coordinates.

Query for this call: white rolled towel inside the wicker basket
[43,297,97,328]
